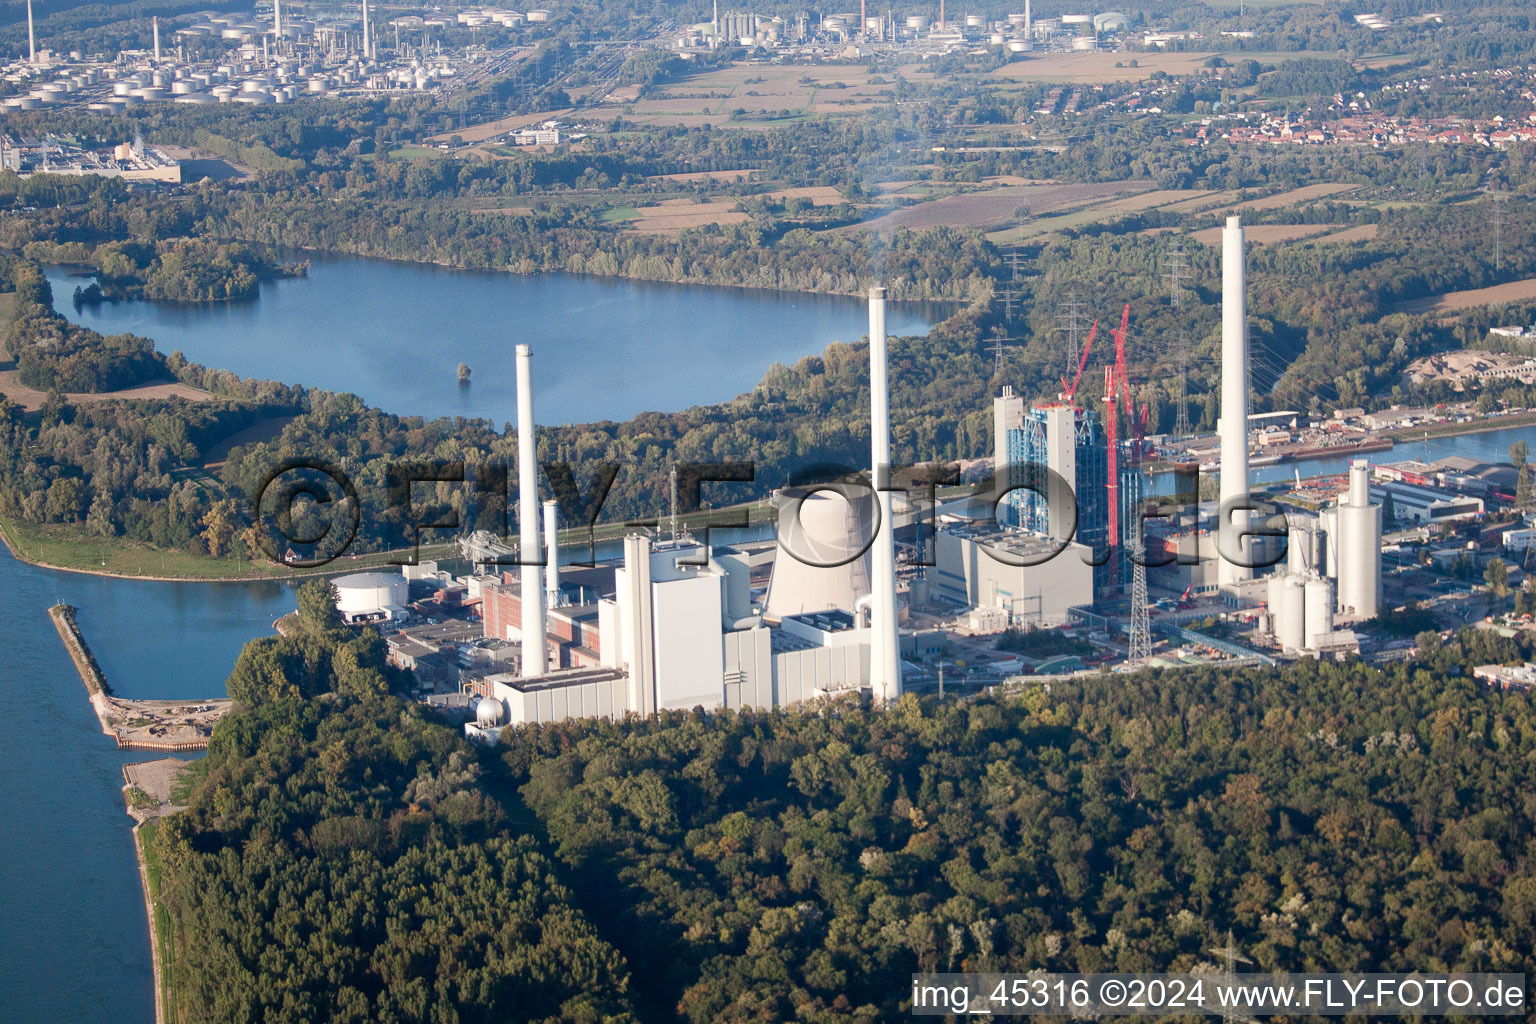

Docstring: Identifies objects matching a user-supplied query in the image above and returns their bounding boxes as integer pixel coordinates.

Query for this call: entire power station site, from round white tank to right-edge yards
[276,216,1536,738]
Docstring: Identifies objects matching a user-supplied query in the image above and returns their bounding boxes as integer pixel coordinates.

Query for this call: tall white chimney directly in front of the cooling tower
[869,286,902,702]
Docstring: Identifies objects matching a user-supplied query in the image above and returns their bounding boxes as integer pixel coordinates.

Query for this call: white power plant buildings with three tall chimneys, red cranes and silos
[465,216,1382,738]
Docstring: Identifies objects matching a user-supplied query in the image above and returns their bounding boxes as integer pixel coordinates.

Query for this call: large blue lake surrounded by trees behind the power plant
[48,260,946,425]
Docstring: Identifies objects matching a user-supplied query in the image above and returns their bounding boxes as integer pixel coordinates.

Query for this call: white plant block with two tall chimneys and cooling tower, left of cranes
[464,289,902,742]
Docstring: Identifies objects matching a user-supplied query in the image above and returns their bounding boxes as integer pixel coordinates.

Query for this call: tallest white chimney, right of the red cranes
[1217,216,1253,586]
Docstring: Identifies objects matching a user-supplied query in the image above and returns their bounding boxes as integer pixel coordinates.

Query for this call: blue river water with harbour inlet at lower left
[0,545,293,1024]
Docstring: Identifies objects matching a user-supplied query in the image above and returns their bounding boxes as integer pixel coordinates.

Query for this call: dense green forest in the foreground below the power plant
[157,623,1536,1024]
